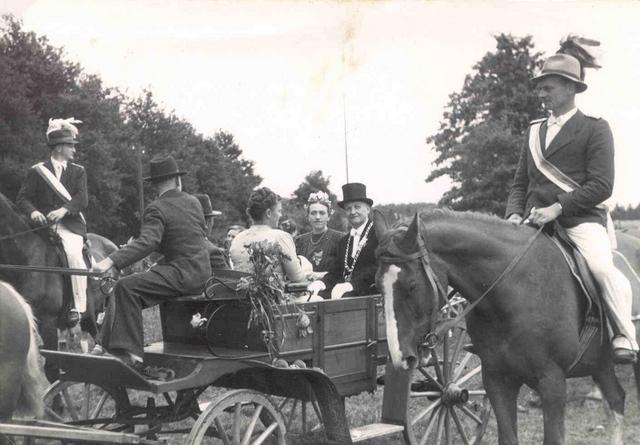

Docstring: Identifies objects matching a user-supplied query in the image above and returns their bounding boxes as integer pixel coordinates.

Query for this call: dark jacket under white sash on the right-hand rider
[505,110,614,227]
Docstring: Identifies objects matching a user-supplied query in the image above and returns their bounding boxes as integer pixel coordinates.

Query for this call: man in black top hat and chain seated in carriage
[309,182,378,299]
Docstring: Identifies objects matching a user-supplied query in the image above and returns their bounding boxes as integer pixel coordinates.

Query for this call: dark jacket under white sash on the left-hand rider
[16,159,89,236]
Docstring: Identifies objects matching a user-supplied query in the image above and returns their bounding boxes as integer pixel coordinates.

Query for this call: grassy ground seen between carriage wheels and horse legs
[45,309,640,445]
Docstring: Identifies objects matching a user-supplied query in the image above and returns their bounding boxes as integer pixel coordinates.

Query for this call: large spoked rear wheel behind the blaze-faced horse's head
[404,327,491,445]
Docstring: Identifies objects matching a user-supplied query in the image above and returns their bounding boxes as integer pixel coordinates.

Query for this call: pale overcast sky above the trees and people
[5,0,640,205]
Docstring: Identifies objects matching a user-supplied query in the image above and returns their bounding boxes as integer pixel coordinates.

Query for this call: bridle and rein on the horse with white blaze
[378,222,544,349]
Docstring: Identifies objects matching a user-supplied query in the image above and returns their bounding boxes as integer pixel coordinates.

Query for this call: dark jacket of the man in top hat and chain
[322,220,378,297]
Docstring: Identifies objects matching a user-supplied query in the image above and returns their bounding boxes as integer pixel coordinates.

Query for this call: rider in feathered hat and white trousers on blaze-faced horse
[506,54,638,363]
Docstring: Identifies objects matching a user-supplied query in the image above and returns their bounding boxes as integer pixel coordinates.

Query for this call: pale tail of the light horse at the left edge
[0,283,47,417]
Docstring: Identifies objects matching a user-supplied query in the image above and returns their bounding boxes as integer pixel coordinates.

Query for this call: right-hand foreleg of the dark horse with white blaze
[536,367,567,445]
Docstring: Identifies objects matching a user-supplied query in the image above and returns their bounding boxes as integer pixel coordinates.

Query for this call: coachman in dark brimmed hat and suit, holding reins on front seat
[93,156,211,367]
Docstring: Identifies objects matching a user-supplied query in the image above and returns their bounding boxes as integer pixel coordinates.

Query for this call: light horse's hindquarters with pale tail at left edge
[0,281,46,444]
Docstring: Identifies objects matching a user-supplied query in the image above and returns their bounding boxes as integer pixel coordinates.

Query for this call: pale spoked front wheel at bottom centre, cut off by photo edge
[187,389,286,445]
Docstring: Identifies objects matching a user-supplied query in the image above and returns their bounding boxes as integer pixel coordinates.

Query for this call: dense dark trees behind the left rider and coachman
[0,15,262,242]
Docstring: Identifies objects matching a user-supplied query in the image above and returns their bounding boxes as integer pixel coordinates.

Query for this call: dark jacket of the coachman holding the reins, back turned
[109,189,211,293]
